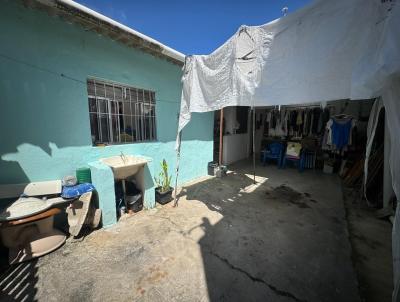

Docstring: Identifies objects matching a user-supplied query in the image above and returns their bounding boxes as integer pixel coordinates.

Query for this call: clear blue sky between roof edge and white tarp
[75,0,311,54]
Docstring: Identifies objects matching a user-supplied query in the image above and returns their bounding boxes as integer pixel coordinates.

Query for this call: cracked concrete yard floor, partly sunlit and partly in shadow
[0,162,360,301]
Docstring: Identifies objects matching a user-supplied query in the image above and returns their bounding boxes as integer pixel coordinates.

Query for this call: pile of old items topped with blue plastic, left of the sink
[0,168,101,263]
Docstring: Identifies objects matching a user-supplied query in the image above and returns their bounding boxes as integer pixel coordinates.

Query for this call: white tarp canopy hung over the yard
[177,0,400,301]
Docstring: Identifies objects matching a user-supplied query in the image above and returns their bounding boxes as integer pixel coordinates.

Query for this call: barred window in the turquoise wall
[87,79,156,145]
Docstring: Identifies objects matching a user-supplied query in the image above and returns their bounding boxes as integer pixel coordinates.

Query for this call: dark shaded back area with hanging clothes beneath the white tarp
[214,100,376,168]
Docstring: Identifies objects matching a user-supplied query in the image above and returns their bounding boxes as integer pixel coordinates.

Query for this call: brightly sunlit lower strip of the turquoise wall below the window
[0,137,213,184]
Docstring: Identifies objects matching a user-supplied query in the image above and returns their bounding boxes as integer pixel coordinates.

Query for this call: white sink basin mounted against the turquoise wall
[100,155,147,179]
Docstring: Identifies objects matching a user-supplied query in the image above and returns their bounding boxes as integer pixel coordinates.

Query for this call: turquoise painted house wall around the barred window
[0,1,213,224]
